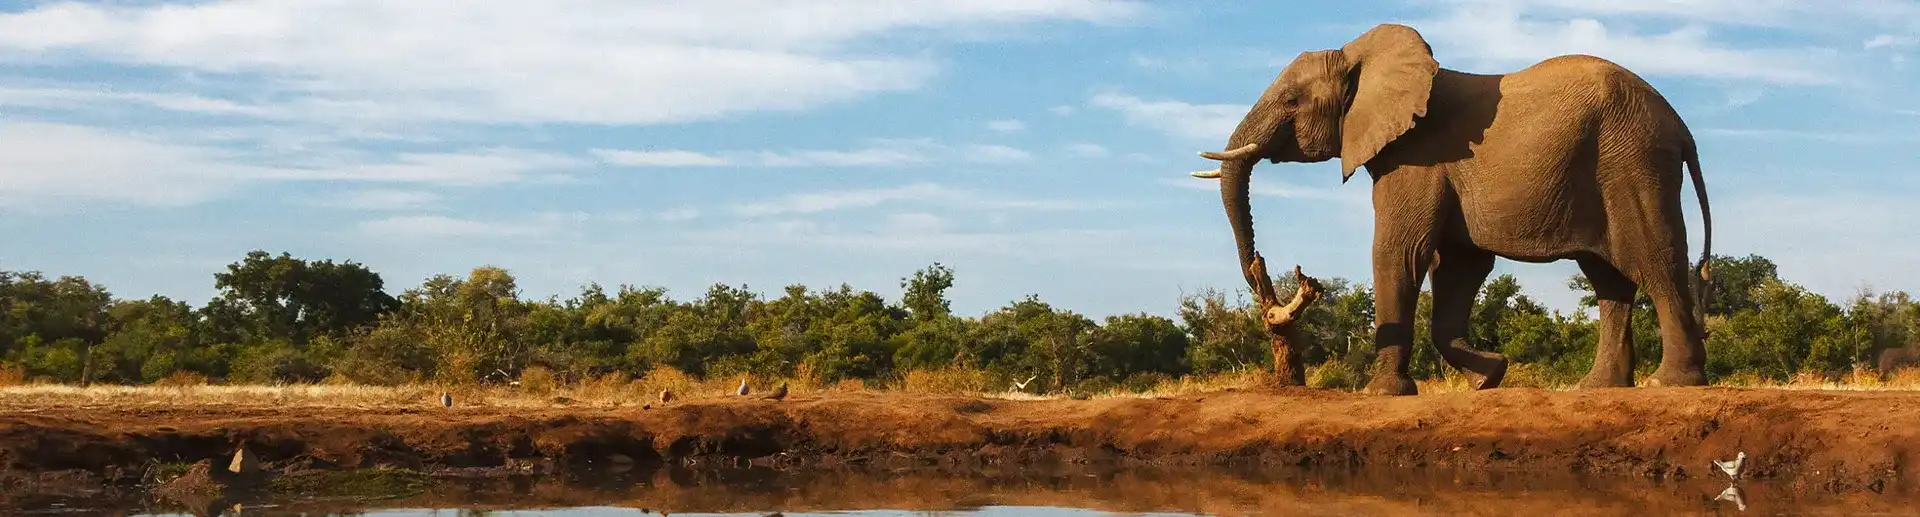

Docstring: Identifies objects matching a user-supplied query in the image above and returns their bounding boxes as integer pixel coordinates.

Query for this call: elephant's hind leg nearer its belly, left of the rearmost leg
[1578,258,1638,388]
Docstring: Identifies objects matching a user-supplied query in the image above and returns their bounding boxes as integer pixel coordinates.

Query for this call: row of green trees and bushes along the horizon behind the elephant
[0,250,1920,392]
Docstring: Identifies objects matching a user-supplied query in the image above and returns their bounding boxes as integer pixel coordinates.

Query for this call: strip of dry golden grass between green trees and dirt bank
[0,365,1920,411]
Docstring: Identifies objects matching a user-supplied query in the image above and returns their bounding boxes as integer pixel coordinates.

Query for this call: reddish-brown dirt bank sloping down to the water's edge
[0,388,1920,494]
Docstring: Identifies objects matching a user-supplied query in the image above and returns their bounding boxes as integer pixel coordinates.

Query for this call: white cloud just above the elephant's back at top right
[1413,2,1837,85]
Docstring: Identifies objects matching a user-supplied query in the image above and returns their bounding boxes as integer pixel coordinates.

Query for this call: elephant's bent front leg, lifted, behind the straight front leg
[1432,246,1507,390]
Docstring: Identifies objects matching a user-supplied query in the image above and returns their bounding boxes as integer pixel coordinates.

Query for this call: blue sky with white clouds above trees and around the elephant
[0,0,1920,317]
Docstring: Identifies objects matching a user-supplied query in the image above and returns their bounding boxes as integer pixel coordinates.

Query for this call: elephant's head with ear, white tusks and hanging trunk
[1192,23,1440,274]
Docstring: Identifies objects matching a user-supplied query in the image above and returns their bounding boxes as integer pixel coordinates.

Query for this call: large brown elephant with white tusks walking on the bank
[1192,25,1713,394]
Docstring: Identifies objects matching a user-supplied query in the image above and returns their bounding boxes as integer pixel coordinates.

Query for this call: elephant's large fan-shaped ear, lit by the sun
[1340,23,1440,183]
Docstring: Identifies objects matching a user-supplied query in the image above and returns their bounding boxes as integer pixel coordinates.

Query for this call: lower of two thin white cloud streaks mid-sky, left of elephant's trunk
[733,183,1092,217]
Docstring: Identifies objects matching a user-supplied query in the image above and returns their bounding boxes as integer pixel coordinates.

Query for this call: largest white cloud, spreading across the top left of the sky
[0,0,1146,125]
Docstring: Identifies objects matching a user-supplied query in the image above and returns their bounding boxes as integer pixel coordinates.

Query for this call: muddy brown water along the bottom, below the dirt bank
[26,467,1920,517]
